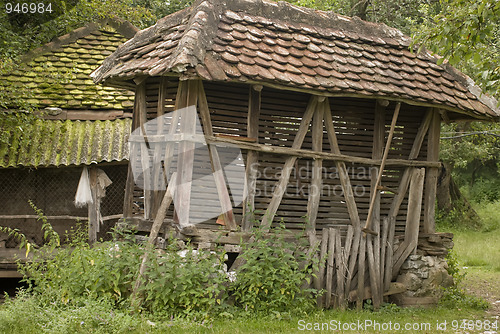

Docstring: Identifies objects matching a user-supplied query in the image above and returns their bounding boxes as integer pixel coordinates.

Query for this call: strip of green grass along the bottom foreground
[0,298,483,334]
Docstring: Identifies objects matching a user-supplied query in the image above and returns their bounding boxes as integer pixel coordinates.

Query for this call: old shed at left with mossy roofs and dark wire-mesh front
[0,19,137,277]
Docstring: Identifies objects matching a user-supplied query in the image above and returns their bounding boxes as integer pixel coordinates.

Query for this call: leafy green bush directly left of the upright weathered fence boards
[231,225,317,312]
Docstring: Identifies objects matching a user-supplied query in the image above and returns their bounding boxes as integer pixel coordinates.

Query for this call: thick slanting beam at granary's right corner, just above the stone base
[392,168,425,278]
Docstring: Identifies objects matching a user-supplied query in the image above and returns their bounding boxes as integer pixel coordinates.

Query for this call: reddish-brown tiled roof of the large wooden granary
[91,0,500,119]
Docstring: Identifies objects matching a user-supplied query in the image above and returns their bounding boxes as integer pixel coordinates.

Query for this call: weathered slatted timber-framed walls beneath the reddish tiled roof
[119,77,441,308]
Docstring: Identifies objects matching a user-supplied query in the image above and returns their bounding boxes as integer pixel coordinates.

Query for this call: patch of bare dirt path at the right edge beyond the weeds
[463,268,500,321]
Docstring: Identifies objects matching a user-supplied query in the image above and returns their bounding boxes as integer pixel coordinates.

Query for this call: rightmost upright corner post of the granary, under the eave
[423,110,441,233]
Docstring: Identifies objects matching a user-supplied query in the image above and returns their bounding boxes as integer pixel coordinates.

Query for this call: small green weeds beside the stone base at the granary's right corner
[439,251,489,310]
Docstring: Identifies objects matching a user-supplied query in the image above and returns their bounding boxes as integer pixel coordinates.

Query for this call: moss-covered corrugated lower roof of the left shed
[0,119,132,168]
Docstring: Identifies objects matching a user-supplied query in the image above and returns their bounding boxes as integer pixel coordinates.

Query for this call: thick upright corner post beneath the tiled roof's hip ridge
[174,80,198,227]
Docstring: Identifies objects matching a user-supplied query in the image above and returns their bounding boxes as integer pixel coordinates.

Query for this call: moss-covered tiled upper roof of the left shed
[0,19,138,110]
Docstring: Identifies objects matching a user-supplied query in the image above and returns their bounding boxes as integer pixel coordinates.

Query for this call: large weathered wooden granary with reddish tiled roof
[92,0,499,307]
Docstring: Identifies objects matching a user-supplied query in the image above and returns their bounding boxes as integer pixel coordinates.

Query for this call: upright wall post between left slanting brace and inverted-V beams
[242,86,262,231]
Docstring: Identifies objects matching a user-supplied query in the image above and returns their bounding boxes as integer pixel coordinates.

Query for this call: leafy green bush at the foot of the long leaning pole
[140,240,228,316]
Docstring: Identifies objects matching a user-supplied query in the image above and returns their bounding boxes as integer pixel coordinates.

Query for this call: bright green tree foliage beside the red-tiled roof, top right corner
[415,0,500,96]
